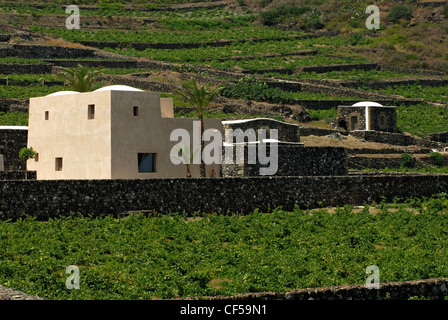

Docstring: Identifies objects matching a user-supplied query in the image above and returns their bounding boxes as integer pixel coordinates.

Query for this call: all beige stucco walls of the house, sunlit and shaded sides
[27,90,222,179]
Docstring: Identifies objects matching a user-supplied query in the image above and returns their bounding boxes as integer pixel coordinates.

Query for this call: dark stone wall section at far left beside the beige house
[0,129,28,171]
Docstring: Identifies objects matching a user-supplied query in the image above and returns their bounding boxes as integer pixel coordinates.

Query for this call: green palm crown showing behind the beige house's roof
[56,64,103,92]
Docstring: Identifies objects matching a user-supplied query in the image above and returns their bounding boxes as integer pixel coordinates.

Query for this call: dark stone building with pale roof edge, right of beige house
[222,119,348,177]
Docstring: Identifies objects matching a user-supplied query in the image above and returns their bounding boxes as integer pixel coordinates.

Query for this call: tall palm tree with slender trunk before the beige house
[175,79,224,177]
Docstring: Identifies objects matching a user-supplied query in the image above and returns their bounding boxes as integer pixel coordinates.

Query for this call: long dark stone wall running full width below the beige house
[0,174,448,220]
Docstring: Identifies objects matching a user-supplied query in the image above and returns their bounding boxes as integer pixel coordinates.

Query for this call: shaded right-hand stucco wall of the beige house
[112,91,222,179]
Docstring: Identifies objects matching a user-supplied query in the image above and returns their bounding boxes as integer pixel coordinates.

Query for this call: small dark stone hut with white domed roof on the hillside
[336,101,397,132]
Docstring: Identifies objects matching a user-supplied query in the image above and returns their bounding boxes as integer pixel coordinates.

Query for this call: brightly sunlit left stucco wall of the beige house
[27,92,111,179]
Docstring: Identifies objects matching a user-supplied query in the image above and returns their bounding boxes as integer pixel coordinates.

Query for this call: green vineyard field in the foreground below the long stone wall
[0,198,448,299]
